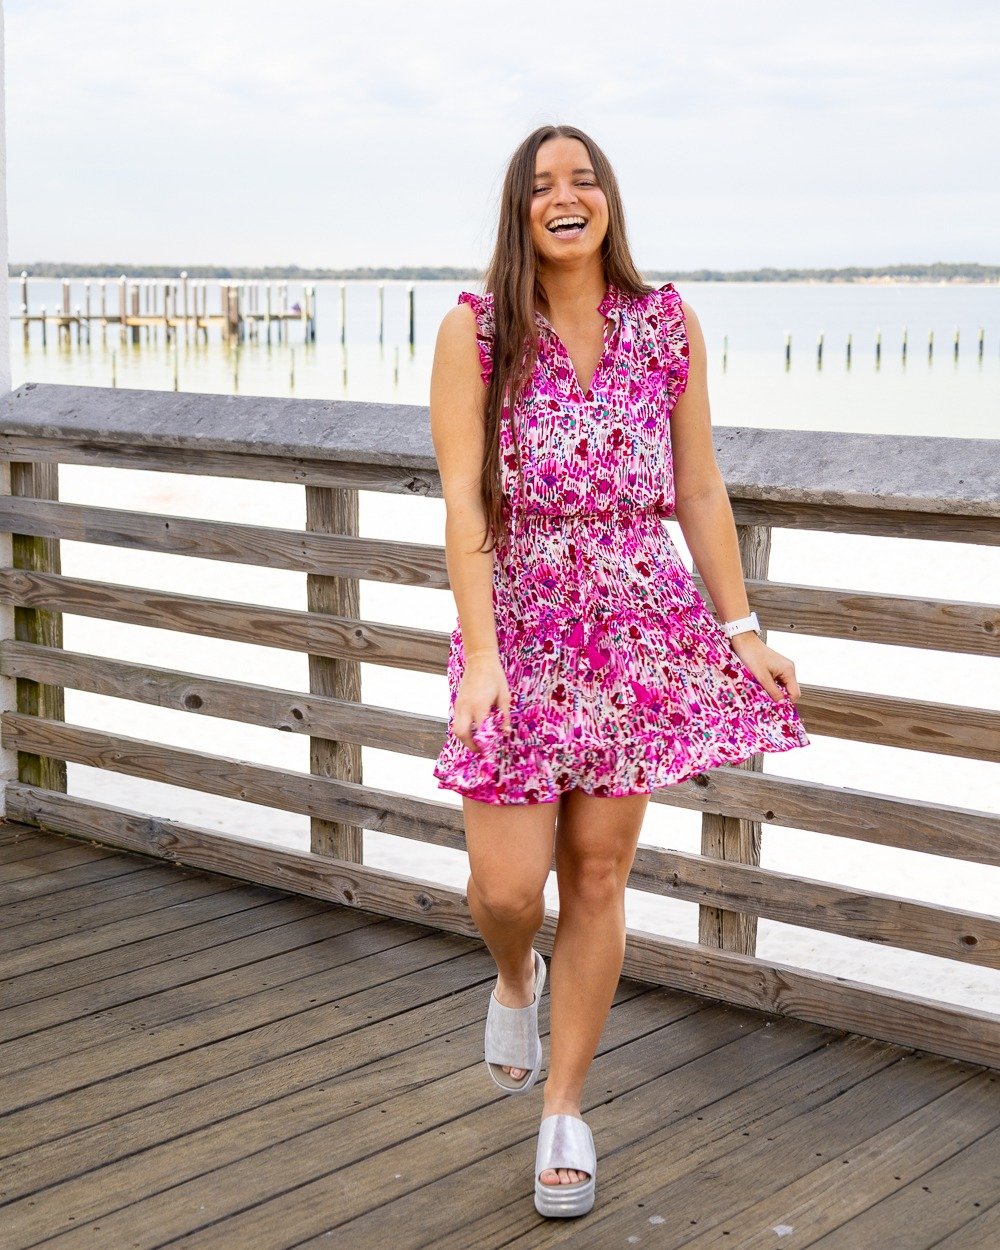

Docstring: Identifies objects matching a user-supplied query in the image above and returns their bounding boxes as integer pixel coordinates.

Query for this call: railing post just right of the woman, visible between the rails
[698,525,771,955]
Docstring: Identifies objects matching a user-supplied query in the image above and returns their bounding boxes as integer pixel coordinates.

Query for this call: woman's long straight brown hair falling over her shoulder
[479,126,653,551]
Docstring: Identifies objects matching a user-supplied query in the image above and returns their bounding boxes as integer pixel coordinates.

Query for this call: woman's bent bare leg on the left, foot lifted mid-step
[463,798,559,1080]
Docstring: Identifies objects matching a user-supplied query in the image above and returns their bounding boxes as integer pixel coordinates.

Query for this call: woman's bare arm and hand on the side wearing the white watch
[670,301,800,703]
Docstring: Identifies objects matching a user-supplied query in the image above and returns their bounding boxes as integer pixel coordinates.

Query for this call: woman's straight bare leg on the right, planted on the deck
[541,790,649,1185]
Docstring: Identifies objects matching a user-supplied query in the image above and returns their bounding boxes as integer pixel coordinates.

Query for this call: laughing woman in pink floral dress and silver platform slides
[430,126,809,1215]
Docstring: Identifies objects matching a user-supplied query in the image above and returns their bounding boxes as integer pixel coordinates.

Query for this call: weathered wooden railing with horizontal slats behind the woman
[0,383,1000,1066]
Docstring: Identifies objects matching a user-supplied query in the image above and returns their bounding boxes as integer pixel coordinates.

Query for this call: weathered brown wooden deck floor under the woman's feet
[0,823,1000,1250]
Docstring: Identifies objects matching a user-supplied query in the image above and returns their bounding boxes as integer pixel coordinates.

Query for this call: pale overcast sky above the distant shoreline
[5,0,1000,271]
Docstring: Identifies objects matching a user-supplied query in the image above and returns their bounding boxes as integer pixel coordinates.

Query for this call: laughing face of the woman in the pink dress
[531,136,608,268]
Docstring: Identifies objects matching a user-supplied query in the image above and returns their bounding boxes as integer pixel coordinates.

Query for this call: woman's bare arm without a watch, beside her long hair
[430,304,500,658]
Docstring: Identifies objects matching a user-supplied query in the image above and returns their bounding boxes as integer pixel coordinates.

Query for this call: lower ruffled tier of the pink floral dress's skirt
[434,600,810,804]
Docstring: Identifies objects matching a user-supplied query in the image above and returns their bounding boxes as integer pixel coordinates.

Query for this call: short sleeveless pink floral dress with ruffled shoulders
[434,283,809,804]
